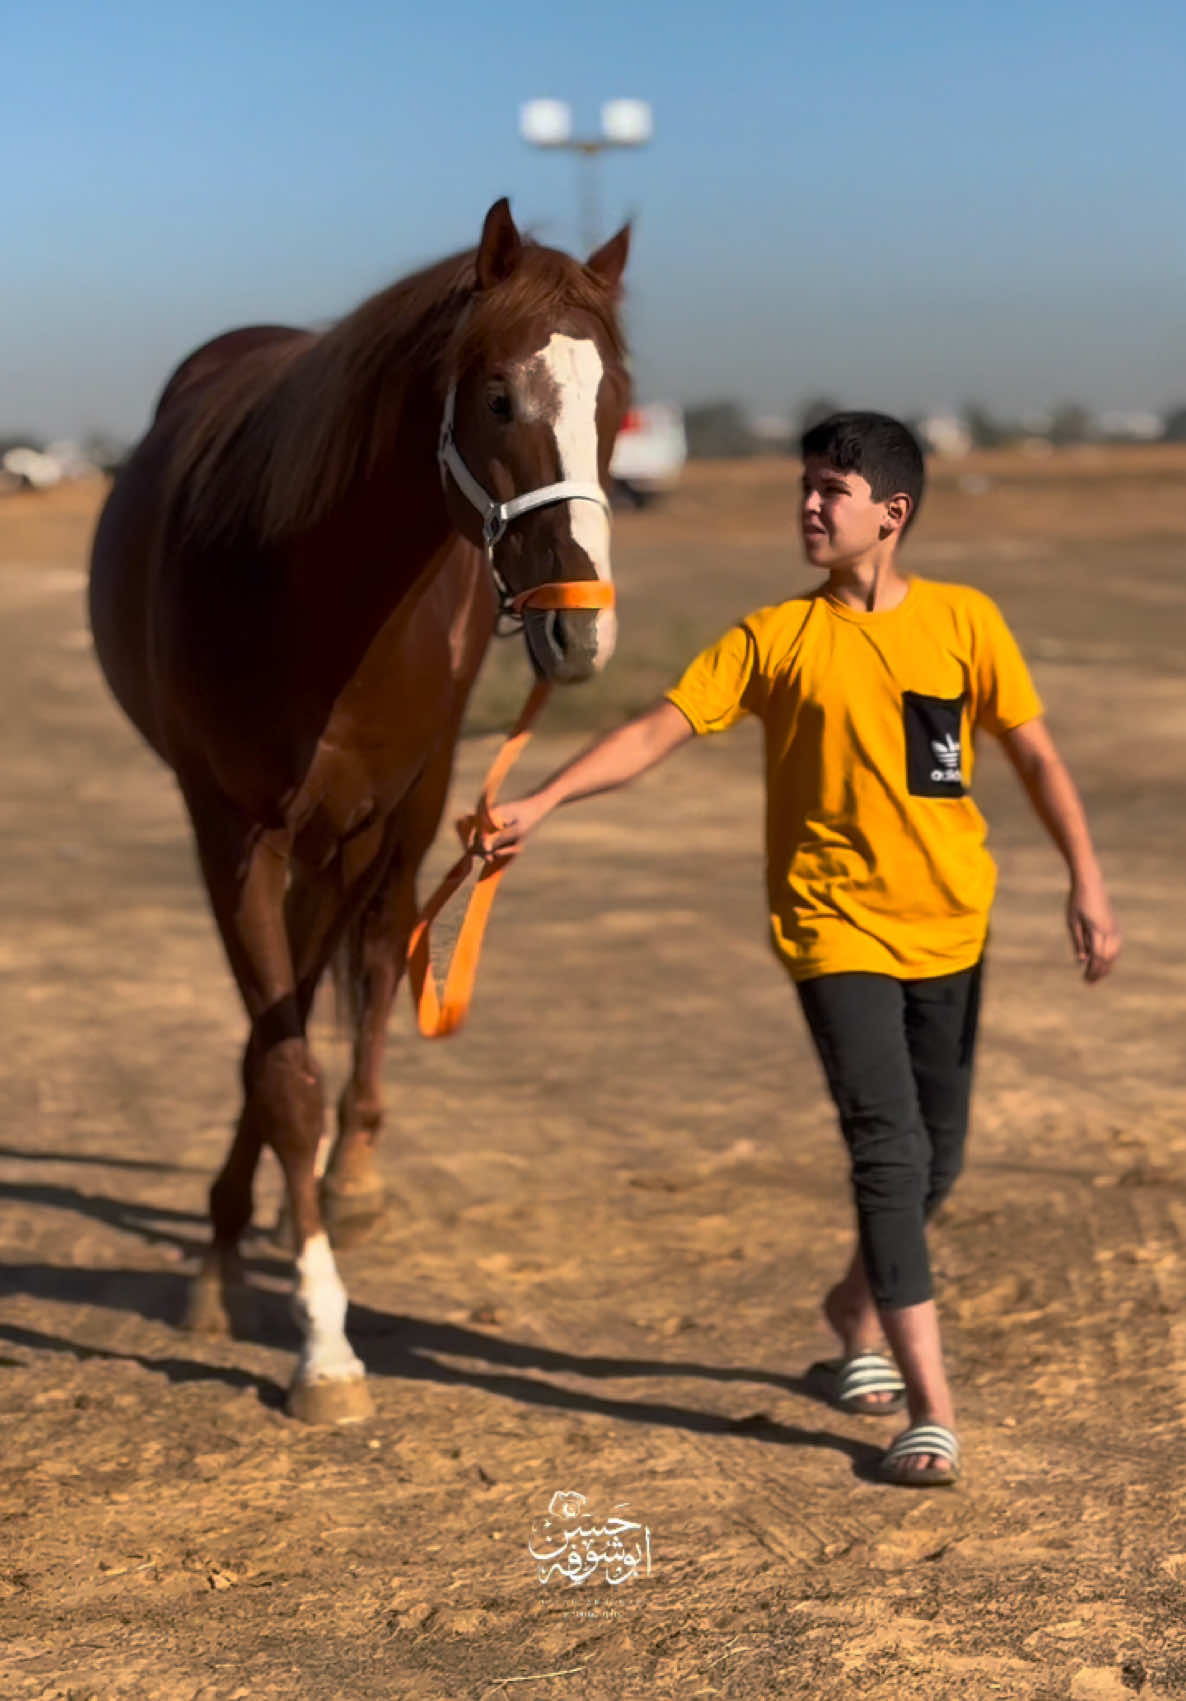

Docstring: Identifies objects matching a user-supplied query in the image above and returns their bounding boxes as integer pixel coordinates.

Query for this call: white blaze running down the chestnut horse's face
[513,332,618,658]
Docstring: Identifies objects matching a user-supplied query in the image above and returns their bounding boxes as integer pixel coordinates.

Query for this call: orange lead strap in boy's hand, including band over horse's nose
[408,578,614,1039]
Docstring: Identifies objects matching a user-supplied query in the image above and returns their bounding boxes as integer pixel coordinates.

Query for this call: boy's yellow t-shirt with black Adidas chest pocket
[667,578,1041,980]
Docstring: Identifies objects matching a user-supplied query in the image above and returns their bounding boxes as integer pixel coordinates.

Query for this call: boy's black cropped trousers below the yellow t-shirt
[796,963,984,1308]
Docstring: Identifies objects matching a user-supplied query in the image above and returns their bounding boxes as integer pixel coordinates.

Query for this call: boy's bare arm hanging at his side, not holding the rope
[1001,718,1121,981]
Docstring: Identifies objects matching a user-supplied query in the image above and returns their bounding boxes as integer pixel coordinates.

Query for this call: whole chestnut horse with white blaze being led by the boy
[90,201,630,1422]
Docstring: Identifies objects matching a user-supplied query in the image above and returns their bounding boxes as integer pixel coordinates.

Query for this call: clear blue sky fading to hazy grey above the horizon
[0,0,1186,434]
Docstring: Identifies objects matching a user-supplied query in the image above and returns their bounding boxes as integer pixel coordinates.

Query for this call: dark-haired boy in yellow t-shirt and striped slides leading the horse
[482,413,1120,1483]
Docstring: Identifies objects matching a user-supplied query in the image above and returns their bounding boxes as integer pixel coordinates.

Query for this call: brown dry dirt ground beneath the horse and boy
[0,451,1186,1701]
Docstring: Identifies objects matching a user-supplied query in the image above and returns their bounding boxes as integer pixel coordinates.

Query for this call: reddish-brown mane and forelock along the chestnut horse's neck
[170,242,624,543]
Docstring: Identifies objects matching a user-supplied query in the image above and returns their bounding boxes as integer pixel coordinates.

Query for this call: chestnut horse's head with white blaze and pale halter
[441,201,630,682]
